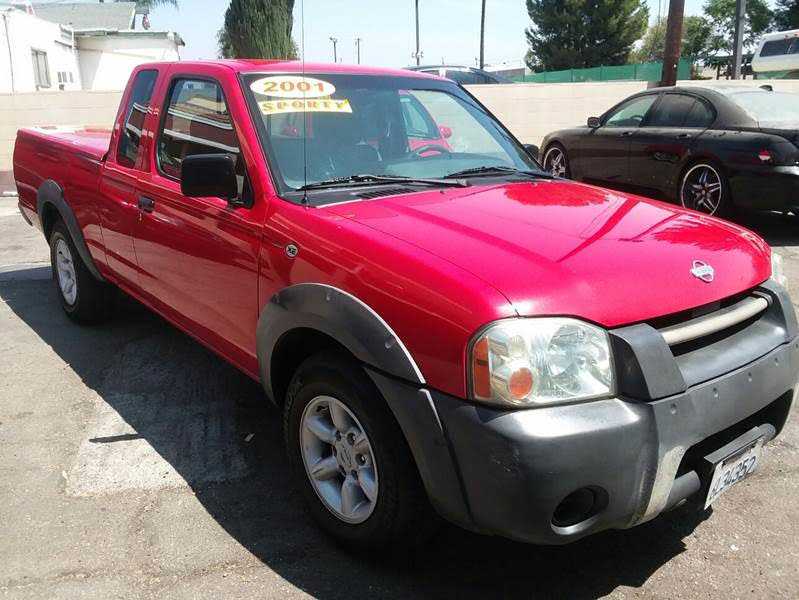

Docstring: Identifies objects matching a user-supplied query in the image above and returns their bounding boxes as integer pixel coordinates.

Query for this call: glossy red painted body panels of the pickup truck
[14,61,770,397]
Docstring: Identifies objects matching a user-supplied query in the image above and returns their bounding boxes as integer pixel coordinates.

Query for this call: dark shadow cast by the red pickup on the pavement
[0,277,716,598]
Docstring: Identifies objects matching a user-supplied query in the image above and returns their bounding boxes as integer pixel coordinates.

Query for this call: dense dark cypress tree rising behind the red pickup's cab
[217,0,297,58]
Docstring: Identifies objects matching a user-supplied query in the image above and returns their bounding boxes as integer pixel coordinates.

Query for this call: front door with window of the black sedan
[580,94,658,184]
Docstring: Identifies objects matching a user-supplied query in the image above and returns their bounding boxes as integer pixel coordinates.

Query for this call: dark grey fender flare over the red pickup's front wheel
[256,283,425,401]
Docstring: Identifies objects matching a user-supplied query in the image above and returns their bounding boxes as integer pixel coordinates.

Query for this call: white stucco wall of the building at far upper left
[0,10,81,93]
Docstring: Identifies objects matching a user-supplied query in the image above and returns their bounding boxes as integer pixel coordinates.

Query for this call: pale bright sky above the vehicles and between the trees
[150,0,768,67]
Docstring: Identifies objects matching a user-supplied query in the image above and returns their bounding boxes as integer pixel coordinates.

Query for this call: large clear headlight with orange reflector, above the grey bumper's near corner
[469,317,615,407]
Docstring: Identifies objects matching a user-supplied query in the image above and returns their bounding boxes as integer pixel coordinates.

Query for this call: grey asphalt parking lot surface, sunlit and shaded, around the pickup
[0,199,799,599]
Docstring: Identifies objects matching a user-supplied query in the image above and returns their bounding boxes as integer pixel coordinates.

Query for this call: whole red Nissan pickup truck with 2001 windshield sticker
[14,60,799,547]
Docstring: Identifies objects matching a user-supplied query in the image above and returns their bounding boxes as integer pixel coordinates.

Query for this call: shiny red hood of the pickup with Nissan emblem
[324,181,771,327]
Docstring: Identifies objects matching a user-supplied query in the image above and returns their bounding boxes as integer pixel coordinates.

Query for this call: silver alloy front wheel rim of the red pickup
[300,396,378,524]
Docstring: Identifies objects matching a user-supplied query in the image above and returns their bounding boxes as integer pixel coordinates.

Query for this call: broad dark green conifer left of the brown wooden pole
[525,0,649,71]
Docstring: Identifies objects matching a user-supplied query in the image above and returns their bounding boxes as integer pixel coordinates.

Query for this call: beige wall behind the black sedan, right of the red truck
[469,79,799,144]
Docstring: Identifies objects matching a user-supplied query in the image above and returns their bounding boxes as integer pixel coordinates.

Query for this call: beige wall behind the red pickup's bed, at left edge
[0,92,122,171]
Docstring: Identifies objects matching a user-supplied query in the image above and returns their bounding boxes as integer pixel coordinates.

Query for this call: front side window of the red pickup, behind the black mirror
[158,79,243,189]
